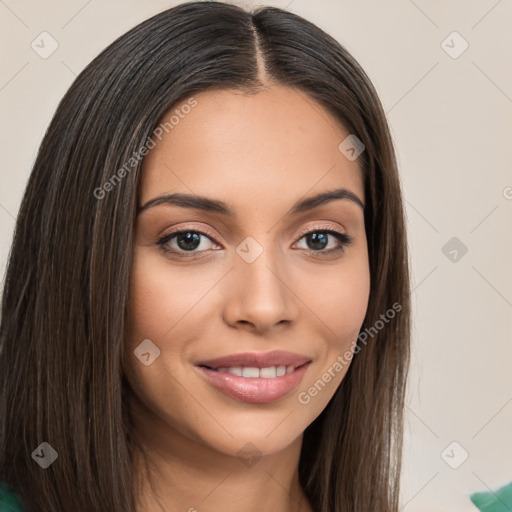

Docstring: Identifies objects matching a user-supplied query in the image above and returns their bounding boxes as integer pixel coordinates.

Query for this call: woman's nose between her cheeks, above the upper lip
[223,245,299,333]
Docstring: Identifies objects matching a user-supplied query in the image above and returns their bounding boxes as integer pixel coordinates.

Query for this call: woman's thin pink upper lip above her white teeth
[196,350,311,368]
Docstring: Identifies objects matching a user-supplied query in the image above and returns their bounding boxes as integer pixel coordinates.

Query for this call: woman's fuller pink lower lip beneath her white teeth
[197,363,309,404]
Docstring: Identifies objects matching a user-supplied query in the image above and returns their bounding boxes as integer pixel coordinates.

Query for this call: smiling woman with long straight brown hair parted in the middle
[0,2,410,512]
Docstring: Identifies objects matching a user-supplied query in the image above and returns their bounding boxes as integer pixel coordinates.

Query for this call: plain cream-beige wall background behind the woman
[0,0,512,512]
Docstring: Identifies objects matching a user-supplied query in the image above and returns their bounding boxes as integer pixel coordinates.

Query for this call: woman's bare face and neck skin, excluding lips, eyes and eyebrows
[125,85,370,512]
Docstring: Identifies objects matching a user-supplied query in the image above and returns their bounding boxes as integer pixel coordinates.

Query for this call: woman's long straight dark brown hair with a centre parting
[0,2,410,512]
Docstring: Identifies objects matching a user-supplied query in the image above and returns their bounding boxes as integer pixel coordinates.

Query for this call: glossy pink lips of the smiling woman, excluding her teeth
[196,350,311,403]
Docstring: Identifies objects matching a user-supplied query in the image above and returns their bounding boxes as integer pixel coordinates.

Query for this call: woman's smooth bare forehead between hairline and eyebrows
[140,85,364,212]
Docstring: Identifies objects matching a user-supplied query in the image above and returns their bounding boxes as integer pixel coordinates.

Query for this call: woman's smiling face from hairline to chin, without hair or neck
[125,86,370,455]
